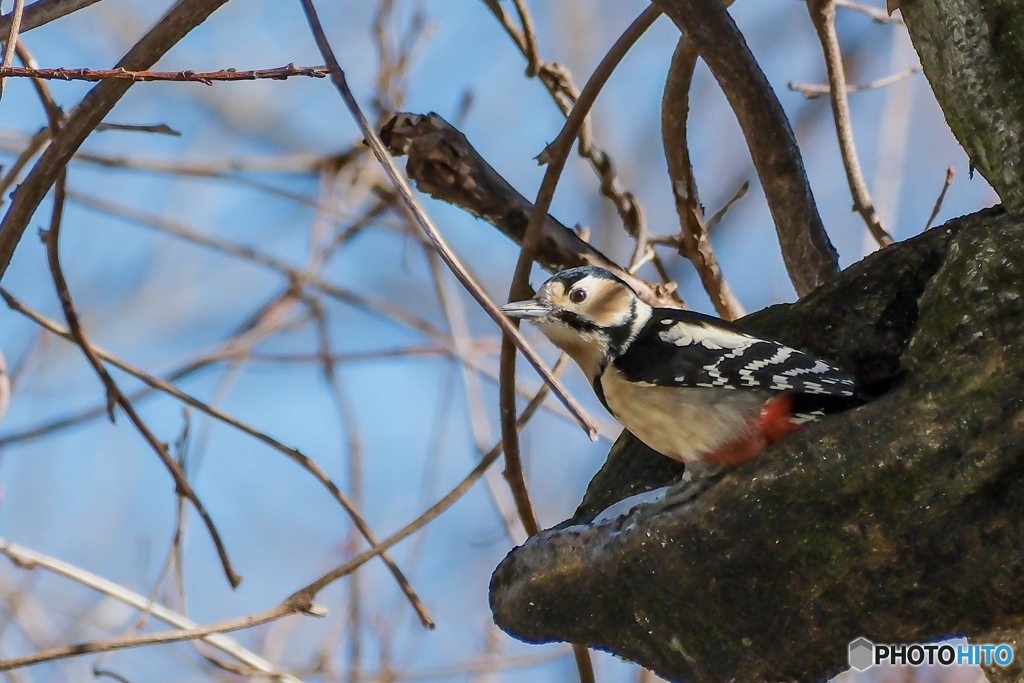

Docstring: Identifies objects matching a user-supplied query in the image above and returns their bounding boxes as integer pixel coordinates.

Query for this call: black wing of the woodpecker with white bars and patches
[614,308,856,398]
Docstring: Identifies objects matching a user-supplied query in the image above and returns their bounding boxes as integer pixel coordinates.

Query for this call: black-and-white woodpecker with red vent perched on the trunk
[502,266,858,479]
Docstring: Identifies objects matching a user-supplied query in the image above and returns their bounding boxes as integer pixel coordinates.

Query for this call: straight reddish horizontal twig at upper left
[0,63,328,85]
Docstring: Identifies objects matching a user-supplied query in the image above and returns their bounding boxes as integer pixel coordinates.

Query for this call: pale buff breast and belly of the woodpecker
[601,365,768,463]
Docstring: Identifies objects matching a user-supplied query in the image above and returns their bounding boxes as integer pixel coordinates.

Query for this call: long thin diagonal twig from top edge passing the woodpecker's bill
[302,0,597,439]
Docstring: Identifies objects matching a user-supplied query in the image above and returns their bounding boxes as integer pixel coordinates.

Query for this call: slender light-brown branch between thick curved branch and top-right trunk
[807,0,893,247]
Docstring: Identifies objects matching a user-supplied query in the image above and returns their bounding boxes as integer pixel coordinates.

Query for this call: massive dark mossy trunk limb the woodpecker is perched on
[490,210,1024,681]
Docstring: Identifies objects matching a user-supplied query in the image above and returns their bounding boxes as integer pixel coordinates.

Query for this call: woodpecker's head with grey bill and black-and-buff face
[502,266,651,380]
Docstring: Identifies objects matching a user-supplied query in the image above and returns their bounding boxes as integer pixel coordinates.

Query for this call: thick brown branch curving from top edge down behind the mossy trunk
[654,0,839,297]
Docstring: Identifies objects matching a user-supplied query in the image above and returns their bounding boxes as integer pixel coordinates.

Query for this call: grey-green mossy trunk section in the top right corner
[900,0,1024,211]
